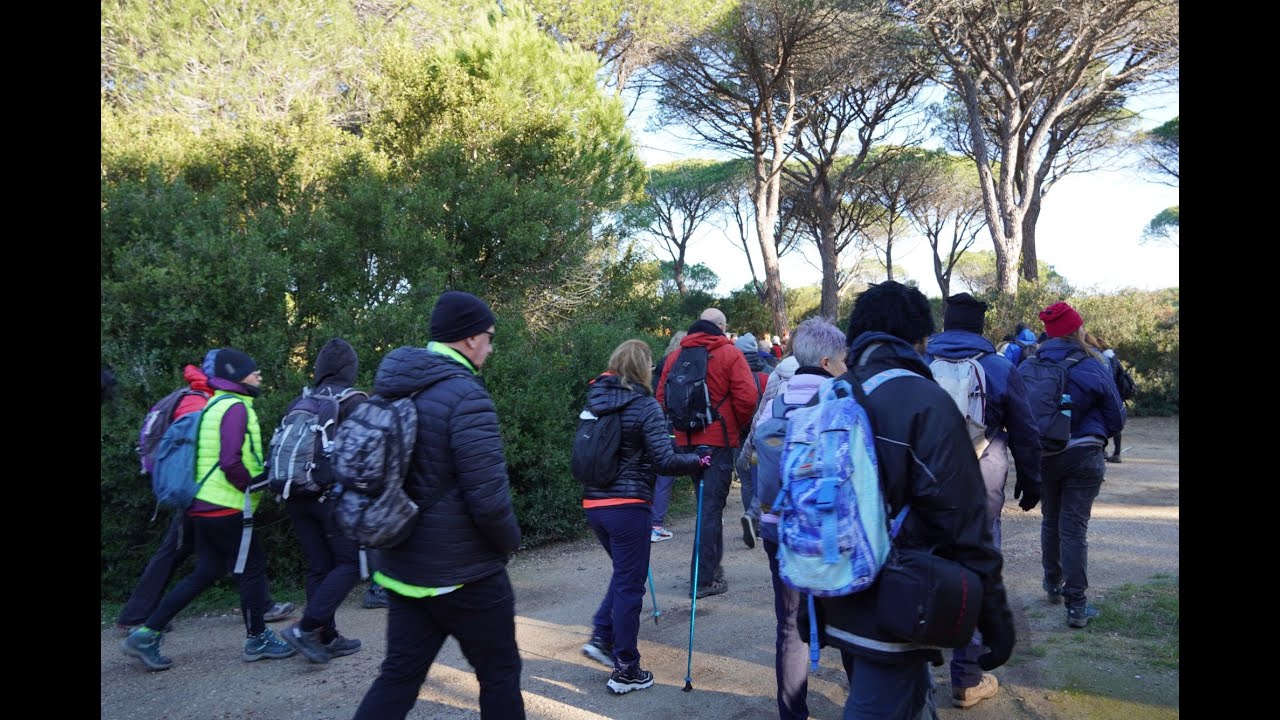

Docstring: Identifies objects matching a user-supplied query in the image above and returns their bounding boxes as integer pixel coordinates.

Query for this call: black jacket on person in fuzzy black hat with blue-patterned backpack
[822,332,1012,664]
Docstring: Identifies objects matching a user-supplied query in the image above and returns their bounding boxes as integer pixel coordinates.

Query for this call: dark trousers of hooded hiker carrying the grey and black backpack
[284,500,360,642]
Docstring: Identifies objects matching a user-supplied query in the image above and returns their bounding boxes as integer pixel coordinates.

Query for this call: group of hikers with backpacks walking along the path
[110,281,1126,720]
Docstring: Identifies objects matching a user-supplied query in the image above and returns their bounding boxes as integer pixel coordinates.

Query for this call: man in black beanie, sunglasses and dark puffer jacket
[355,291,525,720]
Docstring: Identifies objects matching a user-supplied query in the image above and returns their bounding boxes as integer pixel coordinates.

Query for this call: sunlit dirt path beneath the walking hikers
[101,418,1179,720]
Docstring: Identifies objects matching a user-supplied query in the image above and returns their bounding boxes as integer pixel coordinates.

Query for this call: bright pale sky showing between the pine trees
[628,91,1179,297]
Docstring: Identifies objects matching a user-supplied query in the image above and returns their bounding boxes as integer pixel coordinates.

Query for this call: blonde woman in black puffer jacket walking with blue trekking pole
[582,340,710,694]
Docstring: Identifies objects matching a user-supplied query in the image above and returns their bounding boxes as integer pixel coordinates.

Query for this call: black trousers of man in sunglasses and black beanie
[355,570,525,720]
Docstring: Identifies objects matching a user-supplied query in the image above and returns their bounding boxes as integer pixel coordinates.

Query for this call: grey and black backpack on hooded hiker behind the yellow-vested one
[268,387,369,500]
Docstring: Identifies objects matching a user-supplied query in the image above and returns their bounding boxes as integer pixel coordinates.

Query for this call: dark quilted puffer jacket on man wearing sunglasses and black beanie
[374,342,520,588]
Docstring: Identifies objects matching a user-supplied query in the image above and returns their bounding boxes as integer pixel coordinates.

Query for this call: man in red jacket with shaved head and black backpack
[658,307,758,597]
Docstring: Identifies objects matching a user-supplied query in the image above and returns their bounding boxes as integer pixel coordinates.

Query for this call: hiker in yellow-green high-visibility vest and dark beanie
[122,347,294,670]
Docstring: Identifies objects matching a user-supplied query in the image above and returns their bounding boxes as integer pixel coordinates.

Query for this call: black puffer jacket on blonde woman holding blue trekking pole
[582,373,699,502]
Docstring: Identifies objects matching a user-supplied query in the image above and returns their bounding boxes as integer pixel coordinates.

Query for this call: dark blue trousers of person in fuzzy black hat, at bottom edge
[845,656,938,720]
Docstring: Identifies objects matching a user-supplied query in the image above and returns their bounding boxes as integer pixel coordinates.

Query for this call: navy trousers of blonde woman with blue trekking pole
[586,505,652,670]
